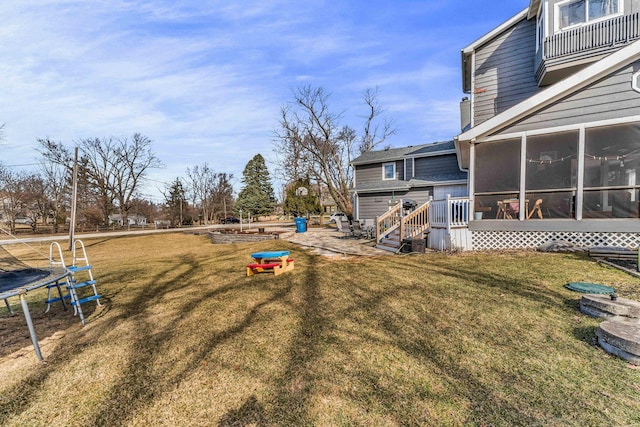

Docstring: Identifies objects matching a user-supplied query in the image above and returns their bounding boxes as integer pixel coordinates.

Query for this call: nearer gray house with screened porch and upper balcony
[455,0,640,249]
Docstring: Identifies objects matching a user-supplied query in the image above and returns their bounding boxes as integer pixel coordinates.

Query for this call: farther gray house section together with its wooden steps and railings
[351,141,469,250]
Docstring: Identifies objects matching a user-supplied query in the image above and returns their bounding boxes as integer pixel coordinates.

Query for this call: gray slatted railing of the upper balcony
[542,13,640,59]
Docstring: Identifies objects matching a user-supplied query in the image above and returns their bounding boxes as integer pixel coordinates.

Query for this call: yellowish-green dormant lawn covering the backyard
[0,234,640,426]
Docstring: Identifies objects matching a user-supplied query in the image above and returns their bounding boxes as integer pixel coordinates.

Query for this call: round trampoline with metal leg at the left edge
[0,267,69,360]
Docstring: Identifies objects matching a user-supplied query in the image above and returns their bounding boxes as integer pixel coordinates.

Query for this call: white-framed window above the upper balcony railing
[556,0,622,30]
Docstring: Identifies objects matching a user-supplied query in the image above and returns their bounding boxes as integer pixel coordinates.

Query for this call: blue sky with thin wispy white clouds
[0,0,529,201]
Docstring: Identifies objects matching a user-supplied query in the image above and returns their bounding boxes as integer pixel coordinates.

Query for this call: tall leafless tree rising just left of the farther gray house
[276,86,395,214]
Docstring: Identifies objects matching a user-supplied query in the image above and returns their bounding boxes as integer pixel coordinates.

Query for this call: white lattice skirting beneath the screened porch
[471,231,640,250]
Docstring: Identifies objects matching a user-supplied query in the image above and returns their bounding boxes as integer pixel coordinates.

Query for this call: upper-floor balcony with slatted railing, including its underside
[535,13,640,86]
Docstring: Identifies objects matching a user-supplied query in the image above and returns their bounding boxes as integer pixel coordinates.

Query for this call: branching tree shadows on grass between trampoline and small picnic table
[0,249,289,425]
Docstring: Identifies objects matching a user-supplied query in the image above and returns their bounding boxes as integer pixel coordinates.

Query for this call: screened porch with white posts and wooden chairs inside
[473,121,640,222]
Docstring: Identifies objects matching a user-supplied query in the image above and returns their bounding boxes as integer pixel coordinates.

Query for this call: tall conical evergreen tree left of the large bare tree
[235,154,276,216]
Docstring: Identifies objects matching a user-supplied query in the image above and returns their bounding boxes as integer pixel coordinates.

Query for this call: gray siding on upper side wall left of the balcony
[473,20,540,126]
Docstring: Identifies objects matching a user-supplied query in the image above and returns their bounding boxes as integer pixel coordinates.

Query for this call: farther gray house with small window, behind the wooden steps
[351,141,469,219]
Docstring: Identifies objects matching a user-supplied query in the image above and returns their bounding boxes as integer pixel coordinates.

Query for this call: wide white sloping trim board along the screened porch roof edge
[458,40,640,141]
